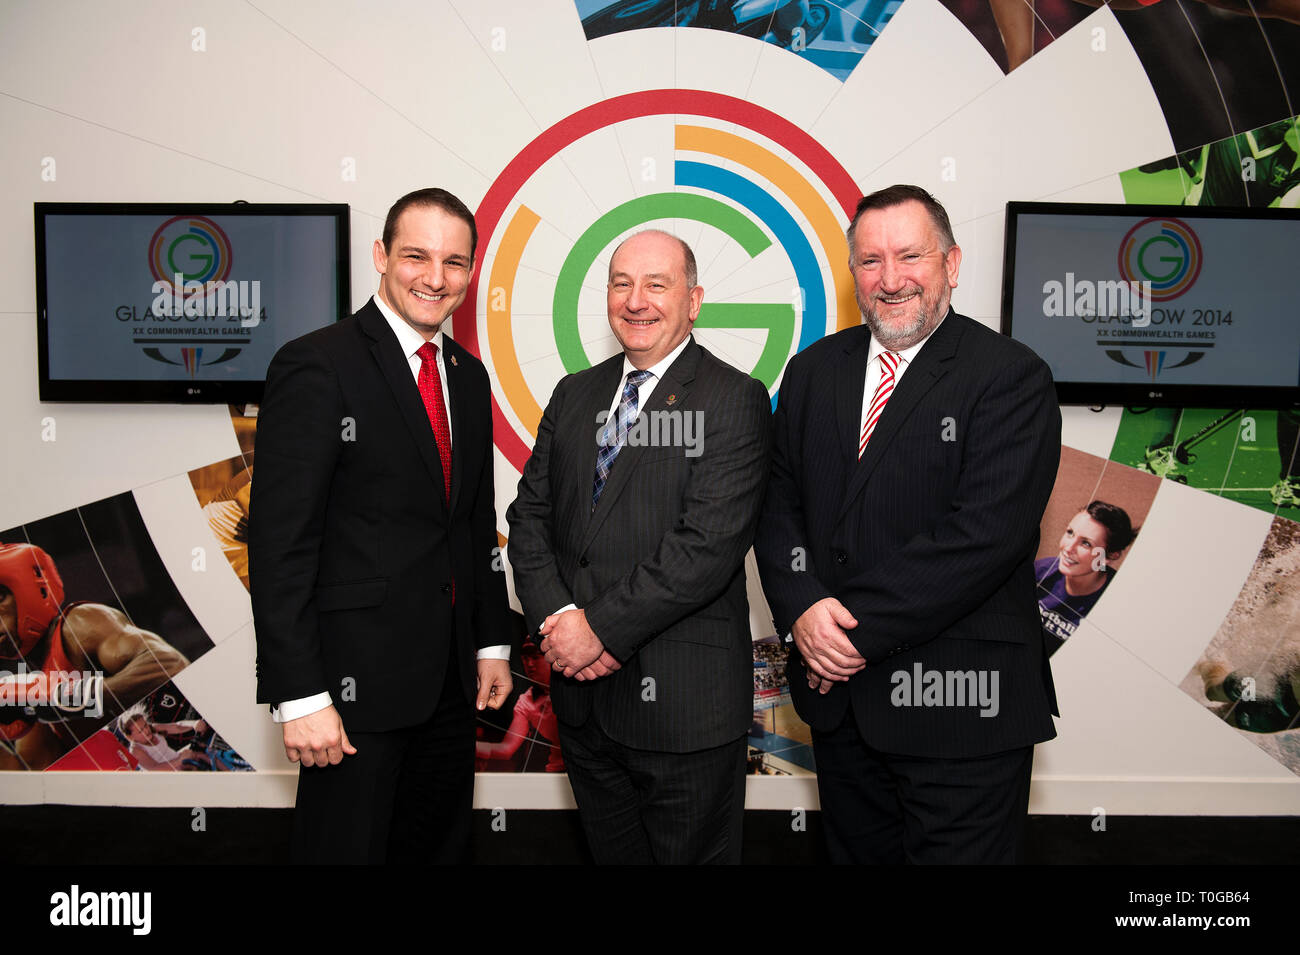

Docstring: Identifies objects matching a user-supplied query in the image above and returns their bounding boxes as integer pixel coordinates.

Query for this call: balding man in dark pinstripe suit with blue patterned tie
[507,231,770,863]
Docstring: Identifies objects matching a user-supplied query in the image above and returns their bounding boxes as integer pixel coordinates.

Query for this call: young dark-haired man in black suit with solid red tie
[248,190,511,863]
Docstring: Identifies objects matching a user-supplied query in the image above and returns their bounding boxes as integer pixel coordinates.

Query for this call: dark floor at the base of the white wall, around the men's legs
[0,806,1300,865]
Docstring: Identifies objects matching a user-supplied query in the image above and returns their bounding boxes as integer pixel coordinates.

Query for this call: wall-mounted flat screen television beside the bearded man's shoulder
[1002,203,1300,408]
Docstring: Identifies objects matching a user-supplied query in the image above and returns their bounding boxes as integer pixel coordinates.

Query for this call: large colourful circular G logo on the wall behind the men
[455,90,862,470]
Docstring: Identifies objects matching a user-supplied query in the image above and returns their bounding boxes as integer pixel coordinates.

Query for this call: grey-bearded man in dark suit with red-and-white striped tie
[755,186,1061,863]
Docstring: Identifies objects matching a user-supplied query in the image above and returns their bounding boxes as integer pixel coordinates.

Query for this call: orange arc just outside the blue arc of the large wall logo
[676,126,862,330]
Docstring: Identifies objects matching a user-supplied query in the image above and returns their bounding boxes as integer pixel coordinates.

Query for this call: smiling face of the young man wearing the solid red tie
[374,205,475,340]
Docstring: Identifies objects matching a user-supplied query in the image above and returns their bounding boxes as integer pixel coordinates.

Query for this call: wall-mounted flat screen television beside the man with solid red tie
[35,203,351,404]
